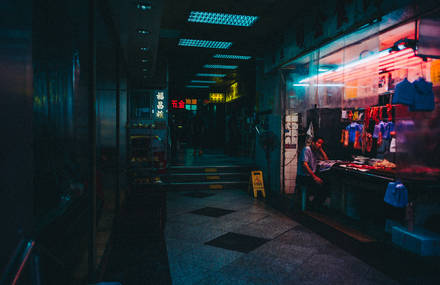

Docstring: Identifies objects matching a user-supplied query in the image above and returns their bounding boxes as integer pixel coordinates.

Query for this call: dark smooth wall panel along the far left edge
[0,0,33,270]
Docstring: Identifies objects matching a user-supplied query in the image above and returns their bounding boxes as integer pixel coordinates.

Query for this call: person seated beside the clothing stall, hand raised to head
[297,137,330,209]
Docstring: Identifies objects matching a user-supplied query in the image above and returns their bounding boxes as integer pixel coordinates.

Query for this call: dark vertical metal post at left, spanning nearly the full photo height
[88,0,96,283]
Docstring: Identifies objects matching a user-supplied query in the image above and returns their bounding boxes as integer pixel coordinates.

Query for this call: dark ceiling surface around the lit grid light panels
[109,0,312,97]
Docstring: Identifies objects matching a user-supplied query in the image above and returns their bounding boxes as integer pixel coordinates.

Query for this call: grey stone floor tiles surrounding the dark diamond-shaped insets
[165,190,398,285]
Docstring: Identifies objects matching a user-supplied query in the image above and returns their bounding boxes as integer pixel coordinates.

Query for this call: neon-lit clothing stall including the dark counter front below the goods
[286,8,440,251]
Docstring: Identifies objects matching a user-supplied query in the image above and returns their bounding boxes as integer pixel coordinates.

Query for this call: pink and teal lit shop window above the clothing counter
[285,14,440,183]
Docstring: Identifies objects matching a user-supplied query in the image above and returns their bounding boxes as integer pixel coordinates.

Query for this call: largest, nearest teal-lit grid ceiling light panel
[188,11,258,27]
